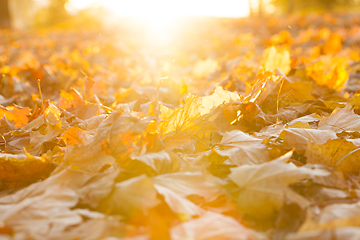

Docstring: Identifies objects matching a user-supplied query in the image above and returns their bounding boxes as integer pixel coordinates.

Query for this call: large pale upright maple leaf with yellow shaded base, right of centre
[229,154,327,219]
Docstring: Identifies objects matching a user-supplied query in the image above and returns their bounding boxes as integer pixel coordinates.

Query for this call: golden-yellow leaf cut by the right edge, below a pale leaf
[305,139,360,172]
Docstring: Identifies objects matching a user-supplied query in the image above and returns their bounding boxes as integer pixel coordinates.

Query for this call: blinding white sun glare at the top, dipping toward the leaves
[69,0,249,43]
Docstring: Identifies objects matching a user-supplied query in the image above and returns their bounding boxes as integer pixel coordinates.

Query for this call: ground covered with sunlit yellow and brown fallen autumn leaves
[0,15,360,240]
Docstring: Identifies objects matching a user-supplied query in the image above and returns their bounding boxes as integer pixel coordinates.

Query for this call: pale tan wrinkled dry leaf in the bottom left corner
[0,185,82,239]
